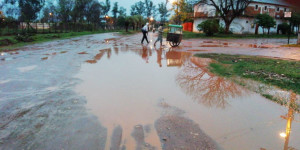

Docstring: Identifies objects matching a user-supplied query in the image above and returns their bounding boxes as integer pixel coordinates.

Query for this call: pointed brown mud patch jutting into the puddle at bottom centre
[155,101,219,150]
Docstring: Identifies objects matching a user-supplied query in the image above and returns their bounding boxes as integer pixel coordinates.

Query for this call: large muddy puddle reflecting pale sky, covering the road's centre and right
[76,35,300,150]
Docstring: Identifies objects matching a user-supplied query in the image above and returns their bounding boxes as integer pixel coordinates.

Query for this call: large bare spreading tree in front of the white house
[201,0,252,33]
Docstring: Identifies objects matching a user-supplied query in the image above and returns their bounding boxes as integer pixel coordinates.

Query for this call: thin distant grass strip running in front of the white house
[164,31,296,39]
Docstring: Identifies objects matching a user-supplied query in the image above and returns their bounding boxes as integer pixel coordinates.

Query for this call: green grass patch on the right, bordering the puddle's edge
[196,54,300,94]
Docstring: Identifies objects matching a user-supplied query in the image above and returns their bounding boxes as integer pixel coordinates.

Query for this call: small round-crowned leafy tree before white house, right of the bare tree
[255,14,276,34]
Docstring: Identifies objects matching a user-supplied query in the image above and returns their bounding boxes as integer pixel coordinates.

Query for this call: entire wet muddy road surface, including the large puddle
[0,34,300,150]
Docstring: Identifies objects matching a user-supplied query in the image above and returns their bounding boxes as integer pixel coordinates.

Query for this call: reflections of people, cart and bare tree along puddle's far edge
[86,42,245,108]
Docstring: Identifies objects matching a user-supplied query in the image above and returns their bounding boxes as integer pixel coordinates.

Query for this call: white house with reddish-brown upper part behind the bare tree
[193,0,292,34]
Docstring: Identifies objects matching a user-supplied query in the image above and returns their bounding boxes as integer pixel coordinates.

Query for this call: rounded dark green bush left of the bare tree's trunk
[197,19,220,36]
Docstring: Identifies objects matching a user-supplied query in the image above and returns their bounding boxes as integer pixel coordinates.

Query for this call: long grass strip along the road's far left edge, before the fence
[0,30,138,51]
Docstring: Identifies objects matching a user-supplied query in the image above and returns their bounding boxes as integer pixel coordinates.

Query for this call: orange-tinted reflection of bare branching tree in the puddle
[176,57,244,108]
